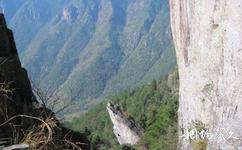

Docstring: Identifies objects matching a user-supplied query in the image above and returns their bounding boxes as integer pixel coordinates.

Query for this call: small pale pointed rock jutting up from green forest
[107,103,144,145]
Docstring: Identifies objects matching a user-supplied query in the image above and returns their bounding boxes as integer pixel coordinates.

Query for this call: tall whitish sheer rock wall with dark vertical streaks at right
[170,0,242,150]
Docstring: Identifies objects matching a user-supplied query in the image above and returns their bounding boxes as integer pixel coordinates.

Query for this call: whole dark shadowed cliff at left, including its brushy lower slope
[0,14,89,149]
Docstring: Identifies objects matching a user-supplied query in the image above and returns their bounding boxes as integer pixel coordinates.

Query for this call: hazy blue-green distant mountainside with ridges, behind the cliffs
[0,0,176,106]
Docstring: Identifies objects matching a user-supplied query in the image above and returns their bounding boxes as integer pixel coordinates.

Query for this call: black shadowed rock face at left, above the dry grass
[0,14,37,138]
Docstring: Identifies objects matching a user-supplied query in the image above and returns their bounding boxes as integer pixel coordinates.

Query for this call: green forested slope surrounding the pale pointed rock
[66,69,178,150]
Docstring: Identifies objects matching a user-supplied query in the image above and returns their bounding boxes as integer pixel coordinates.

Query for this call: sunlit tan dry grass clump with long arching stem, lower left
[0,115,82,150]
